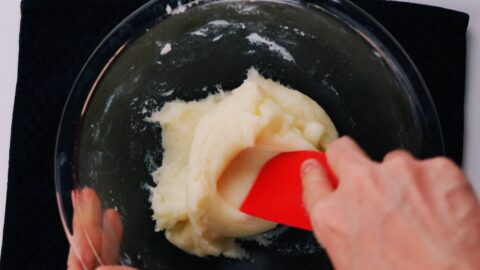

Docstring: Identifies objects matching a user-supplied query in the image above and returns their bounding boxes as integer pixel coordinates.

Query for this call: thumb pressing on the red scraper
[301,159,334,214]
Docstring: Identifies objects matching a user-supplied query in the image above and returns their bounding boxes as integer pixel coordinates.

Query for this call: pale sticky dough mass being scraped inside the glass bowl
[151,69,338,258]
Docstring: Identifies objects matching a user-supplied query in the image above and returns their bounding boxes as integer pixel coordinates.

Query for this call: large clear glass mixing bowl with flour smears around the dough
[55,0,443,270]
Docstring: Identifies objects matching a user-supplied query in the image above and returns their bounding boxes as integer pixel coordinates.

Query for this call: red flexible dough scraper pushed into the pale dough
[240,151,338,231]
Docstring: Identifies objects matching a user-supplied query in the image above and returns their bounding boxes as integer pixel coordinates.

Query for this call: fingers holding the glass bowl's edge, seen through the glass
[67,188,137,270]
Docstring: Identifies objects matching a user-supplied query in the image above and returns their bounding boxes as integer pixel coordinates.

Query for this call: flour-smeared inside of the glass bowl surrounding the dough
[60,1,444,269]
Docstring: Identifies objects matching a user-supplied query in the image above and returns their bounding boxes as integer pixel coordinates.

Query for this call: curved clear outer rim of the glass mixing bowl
[54,0,444,266]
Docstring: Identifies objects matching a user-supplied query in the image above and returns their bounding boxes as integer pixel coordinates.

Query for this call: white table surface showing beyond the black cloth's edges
[0,0,480,258]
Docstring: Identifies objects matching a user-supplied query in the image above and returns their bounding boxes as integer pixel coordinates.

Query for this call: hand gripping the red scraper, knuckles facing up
[302,137,480,270]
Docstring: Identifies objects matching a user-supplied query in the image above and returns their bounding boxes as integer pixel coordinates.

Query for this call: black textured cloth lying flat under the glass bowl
[0,0,468,270]
